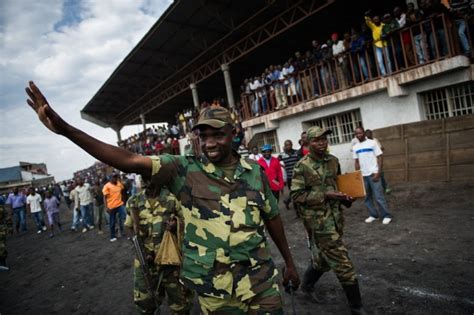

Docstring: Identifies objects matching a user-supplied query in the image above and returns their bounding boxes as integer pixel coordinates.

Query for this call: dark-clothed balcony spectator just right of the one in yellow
[382,13,403,73]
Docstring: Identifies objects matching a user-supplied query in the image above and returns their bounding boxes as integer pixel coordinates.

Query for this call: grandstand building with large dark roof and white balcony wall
[81,0,474,178]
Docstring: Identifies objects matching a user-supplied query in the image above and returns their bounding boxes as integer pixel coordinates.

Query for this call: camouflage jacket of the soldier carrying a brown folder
[290,154,340,222]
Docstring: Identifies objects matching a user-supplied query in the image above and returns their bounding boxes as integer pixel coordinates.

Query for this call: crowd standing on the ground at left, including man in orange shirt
[0,162,140,241]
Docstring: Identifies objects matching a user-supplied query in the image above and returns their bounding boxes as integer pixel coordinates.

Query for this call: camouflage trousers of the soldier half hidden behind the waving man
[133,259,193,314]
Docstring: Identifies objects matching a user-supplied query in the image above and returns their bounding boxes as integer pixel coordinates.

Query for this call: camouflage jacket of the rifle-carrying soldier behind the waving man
[125,188,182,254]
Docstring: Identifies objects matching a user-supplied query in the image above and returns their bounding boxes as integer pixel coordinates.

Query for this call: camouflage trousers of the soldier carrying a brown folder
[311,211,357,285]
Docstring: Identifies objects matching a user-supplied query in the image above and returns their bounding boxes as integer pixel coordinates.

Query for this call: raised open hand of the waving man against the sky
[25,81,68,134]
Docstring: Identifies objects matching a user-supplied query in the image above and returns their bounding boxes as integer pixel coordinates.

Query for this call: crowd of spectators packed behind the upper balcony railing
[240,0,473,119]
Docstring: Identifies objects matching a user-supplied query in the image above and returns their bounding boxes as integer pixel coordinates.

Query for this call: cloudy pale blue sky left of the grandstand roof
[0,0,172,180]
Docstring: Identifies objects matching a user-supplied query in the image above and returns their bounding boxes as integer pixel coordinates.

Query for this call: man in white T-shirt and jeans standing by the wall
[352,127,392,224]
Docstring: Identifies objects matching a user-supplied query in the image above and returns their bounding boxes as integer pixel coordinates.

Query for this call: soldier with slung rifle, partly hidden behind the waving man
[125,187,193,314]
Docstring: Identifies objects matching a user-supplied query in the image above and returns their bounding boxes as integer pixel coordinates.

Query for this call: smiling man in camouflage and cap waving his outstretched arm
[26,82,299,314]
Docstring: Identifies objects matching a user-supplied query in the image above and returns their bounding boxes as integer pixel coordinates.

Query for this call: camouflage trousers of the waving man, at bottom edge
[199,283,283,315]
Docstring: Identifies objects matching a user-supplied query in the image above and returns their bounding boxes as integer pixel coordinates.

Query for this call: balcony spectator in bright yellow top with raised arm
[365,11,392,76]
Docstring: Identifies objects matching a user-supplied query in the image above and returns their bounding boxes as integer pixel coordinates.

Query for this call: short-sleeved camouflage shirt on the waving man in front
[151,155,279,300]
